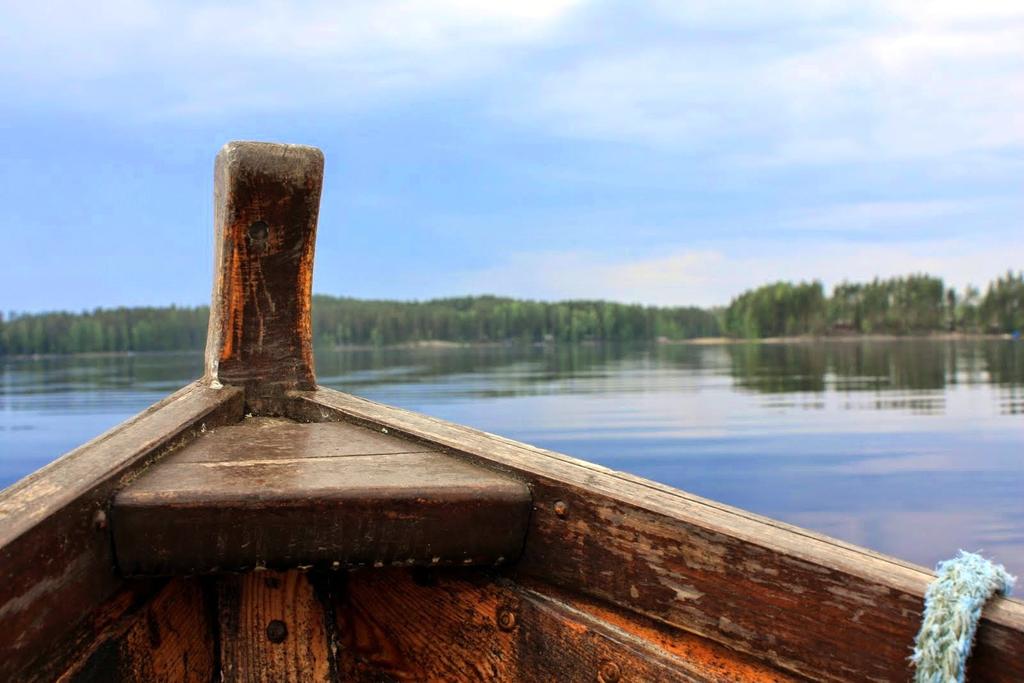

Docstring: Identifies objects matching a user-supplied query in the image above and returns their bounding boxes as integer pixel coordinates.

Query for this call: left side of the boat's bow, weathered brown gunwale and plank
[0,384,243,680]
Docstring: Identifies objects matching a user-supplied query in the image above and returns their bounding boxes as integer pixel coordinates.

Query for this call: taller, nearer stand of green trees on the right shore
[722,272,1024,338]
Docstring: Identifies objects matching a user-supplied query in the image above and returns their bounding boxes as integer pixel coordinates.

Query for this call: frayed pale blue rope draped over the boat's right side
[910,550,1016,683]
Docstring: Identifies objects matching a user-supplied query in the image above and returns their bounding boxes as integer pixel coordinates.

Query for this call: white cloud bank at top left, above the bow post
[0,0,577,115]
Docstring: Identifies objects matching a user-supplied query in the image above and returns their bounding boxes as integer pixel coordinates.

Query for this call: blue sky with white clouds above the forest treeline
[0,0,1024,311]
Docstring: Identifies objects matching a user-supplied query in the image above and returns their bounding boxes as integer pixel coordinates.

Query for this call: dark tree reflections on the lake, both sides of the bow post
[9,340,1024,414]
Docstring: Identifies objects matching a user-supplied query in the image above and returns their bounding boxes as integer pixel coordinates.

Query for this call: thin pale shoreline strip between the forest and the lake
[0,332,1013,360]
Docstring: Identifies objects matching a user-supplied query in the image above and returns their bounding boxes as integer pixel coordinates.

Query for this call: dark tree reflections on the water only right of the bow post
[316,340,1024,411]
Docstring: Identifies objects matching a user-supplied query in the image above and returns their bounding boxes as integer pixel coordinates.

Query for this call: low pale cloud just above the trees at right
[450,239,1024,306]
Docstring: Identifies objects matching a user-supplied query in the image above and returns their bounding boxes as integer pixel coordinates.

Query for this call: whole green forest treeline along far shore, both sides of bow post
[0,272,1024,355]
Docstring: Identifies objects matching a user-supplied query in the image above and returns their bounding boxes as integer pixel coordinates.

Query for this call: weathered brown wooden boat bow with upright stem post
[0,142,1024,683]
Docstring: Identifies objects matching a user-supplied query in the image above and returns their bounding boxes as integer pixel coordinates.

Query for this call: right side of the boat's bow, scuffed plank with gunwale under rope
[289,388,1024,681]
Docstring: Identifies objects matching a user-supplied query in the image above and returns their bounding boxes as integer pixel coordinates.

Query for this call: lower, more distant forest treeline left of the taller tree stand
[0,295,721,354]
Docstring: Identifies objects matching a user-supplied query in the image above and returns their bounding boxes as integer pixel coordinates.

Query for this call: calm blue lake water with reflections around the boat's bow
[0,340,1024,573]
